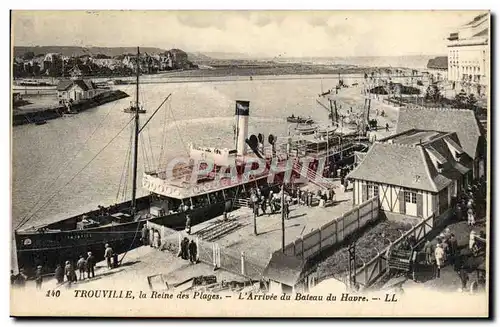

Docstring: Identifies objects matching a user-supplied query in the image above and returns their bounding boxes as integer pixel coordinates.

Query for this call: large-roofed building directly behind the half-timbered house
[396,107,487,179]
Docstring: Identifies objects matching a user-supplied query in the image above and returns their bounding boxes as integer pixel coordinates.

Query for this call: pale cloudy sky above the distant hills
[12,11,486,57]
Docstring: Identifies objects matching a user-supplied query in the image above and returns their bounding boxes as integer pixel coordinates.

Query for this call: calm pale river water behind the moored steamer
[12,76,360,227]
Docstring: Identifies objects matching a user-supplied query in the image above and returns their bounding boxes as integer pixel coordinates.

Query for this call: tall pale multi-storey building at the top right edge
[448,13,490,91]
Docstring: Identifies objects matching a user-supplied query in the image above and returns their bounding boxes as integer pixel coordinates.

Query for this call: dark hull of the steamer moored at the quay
[15,202,225,275]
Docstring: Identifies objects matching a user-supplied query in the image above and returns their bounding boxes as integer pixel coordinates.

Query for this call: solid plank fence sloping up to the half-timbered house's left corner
[285,197,380,260]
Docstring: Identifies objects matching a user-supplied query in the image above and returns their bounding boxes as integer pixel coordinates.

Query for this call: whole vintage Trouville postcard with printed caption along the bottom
[10,10,491,317]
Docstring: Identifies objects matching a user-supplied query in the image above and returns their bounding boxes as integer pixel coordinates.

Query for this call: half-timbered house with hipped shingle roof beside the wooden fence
[348,129,473,218]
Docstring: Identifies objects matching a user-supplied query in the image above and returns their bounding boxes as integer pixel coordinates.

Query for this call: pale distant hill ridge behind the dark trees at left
[14,46,212,62]
